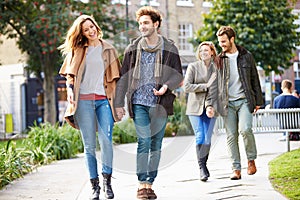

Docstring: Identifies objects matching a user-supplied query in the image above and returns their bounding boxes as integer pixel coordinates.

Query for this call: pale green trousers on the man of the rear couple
[224,99,257,170]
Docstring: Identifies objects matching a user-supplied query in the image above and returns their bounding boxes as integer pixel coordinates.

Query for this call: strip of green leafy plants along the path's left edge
[0,123,83,189]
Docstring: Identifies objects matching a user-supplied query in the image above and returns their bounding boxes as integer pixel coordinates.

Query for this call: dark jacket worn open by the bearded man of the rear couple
[206,45,264,116]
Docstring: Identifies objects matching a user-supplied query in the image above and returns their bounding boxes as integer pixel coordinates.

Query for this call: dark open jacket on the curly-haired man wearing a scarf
[115,37,183,117]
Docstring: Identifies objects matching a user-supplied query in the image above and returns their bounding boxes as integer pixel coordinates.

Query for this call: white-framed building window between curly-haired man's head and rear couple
[178,23,193,52]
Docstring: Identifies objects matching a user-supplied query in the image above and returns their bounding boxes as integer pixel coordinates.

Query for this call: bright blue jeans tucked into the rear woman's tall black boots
[189,110,216,145]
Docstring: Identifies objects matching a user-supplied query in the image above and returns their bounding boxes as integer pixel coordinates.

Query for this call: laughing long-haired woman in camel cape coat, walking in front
[59,15,120,199]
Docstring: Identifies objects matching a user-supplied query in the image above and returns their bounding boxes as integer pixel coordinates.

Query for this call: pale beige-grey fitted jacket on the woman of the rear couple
[183,60,216,115]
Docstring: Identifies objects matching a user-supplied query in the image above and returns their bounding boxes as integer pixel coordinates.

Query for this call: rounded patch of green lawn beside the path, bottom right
[269,149,300,200]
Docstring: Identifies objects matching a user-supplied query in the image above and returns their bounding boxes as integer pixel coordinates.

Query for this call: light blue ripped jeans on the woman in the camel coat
[74,99,114,179]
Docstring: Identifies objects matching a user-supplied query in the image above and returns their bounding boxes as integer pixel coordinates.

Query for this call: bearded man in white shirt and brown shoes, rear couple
[208,26,263,180]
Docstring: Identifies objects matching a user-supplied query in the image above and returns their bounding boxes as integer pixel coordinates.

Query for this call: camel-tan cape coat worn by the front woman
[59,40,121,129]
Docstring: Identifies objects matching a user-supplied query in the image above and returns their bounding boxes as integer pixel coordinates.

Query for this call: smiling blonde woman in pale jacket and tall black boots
[183,41,217,181]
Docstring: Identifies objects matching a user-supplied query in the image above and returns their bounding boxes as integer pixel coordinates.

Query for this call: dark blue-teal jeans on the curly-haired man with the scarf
[133,104,167,184]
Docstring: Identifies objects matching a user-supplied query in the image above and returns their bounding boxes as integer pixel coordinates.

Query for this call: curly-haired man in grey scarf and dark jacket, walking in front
[115,6,183,199]
